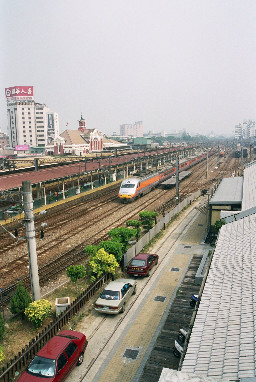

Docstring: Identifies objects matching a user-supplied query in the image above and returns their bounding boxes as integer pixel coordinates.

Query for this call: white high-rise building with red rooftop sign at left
[5,86,59,150]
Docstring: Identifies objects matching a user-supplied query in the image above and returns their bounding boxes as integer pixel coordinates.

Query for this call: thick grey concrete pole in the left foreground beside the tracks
[22,181,40,301]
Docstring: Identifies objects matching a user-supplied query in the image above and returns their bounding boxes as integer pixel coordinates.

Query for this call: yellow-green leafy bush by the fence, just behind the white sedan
[88,248,119,282]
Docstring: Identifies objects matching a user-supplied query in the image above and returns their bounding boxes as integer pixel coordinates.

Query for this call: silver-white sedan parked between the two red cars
[95,279,136,314]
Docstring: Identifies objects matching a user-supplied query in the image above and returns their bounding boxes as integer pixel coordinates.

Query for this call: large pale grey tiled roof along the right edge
[181,162,256,381]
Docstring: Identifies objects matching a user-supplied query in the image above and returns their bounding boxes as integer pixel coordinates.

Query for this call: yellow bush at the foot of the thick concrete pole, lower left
[25,299,52,329]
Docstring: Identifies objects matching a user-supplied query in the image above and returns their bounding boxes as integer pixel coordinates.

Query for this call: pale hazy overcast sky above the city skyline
[0,0,256,135]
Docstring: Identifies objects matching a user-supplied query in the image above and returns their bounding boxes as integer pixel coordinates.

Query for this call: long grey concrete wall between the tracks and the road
[123,191,201,267]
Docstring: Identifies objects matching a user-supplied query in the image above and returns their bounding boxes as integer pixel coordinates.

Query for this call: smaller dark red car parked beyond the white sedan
[126,253,158,276]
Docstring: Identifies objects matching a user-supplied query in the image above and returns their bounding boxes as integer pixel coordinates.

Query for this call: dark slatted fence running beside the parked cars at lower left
[0,274,111,382]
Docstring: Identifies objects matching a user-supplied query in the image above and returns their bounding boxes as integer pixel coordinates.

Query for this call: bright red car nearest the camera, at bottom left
[18,330,88,382]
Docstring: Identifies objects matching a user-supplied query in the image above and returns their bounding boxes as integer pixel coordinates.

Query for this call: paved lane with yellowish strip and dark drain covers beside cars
[67,200,208,382]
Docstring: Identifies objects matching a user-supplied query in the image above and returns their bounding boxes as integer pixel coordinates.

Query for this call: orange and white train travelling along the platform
[118,153,206,202]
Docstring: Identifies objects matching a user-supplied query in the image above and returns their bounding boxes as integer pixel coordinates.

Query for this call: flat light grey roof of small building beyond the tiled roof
[209,176,243,205]
